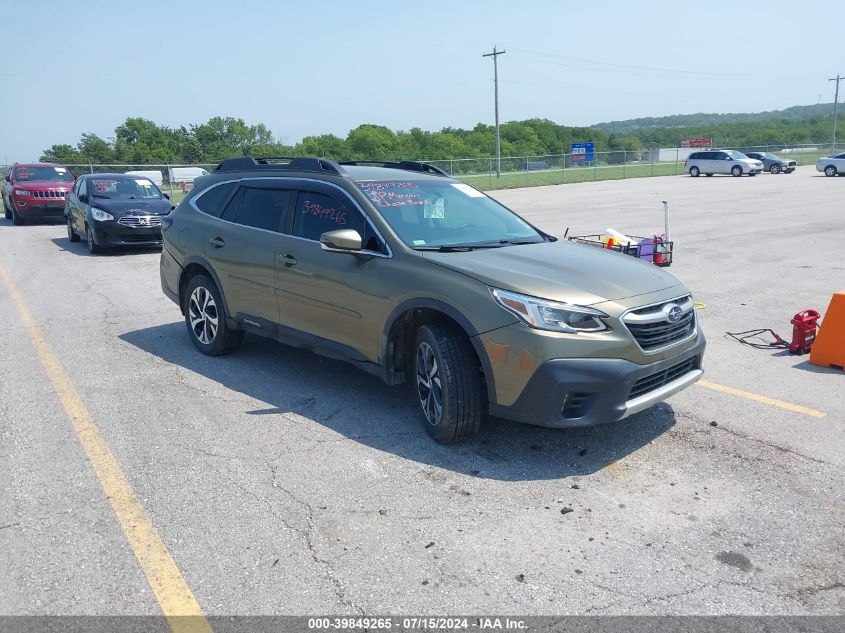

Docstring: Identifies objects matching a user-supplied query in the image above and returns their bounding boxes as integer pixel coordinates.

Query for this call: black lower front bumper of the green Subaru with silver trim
[490,331,706,428]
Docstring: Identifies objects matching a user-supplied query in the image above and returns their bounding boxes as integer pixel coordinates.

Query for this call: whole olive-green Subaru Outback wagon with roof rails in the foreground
[161,157,705,442]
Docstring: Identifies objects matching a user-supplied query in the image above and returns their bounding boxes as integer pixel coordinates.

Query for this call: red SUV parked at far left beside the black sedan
[3,163,74,224]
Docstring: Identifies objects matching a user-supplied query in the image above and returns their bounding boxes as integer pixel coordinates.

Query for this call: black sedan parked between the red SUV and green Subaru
[65,174,173,253]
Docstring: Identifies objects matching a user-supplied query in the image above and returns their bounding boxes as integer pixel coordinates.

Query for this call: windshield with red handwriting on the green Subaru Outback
[356,180,545,249]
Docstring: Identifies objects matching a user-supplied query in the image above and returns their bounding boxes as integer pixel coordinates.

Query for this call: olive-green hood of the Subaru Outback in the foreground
[423,240,681,306]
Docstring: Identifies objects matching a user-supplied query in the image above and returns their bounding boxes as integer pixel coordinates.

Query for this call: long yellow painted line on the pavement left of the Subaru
[0,265,211,633]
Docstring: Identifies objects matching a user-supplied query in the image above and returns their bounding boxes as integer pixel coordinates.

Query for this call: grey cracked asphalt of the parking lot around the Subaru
[0,167,845,615]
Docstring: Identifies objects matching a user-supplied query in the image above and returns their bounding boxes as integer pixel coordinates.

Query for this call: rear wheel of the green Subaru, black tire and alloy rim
[182,275,244,356]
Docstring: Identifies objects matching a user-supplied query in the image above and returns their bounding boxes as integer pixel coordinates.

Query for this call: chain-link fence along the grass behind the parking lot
[0,143,834,202]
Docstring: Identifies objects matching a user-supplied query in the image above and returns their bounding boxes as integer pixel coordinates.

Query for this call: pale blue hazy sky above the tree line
[0,0,845,163]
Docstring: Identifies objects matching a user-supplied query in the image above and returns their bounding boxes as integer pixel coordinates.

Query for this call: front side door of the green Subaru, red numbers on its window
[276,182,392,362]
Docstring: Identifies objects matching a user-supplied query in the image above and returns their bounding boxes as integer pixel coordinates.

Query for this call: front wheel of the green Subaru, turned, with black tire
[413,324,485,444]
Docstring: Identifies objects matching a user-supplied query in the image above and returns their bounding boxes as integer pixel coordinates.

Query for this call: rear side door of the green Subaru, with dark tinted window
[205,180,295,324]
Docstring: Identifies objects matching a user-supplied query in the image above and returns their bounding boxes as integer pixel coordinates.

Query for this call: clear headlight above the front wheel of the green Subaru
[493,288,607,334]
